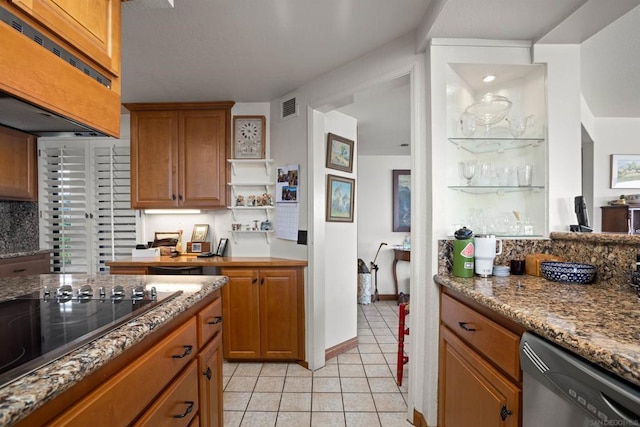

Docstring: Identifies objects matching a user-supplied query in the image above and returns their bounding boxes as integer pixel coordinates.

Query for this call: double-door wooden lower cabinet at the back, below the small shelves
[221,268,304,360]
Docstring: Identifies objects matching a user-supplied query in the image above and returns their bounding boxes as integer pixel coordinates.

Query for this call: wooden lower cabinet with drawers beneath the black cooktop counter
[35,290,223,427]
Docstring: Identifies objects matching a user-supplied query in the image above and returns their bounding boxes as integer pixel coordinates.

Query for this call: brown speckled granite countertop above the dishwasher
[434,274,640,385]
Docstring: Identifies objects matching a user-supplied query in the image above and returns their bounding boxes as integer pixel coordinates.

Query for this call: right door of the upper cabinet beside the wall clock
[178,110,227,208]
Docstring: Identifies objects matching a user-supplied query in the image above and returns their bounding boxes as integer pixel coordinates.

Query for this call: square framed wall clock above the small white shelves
[233,116,266,159]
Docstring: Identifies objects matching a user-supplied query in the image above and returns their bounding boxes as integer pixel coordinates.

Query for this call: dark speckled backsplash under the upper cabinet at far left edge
[0,201,40,254]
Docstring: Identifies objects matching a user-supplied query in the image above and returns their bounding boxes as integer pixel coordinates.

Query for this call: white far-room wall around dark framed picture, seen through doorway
[358,156,411,295]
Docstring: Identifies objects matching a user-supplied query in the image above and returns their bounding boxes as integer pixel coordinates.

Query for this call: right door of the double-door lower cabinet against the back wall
[260,269,304,359]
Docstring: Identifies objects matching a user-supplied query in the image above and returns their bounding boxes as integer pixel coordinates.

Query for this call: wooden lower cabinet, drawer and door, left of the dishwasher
[438,294,522,427]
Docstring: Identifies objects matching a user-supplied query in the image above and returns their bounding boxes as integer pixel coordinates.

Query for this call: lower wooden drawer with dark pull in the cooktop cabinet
[134,361,198,427]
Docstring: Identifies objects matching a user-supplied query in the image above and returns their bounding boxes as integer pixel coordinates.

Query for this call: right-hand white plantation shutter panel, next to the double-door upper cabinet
[91,141,136,273]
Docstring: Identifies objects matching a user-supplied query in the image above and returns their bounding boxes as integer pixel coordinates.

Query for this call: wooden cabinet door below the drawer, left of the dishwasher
[438,326,521,427]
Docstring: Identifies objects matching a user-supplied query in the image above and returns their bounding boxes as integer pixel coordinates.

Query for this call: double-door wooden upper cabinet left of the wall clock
[125,102,233,209]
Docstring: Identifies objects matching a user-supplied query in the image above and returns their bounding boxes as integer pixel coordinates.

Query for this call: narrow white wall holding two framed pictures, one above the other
[316,111,360,348]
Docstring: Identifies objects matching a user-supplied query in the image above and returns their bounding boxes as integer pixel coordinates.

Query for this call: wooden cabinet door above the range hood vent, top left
[11,0,120,76]
